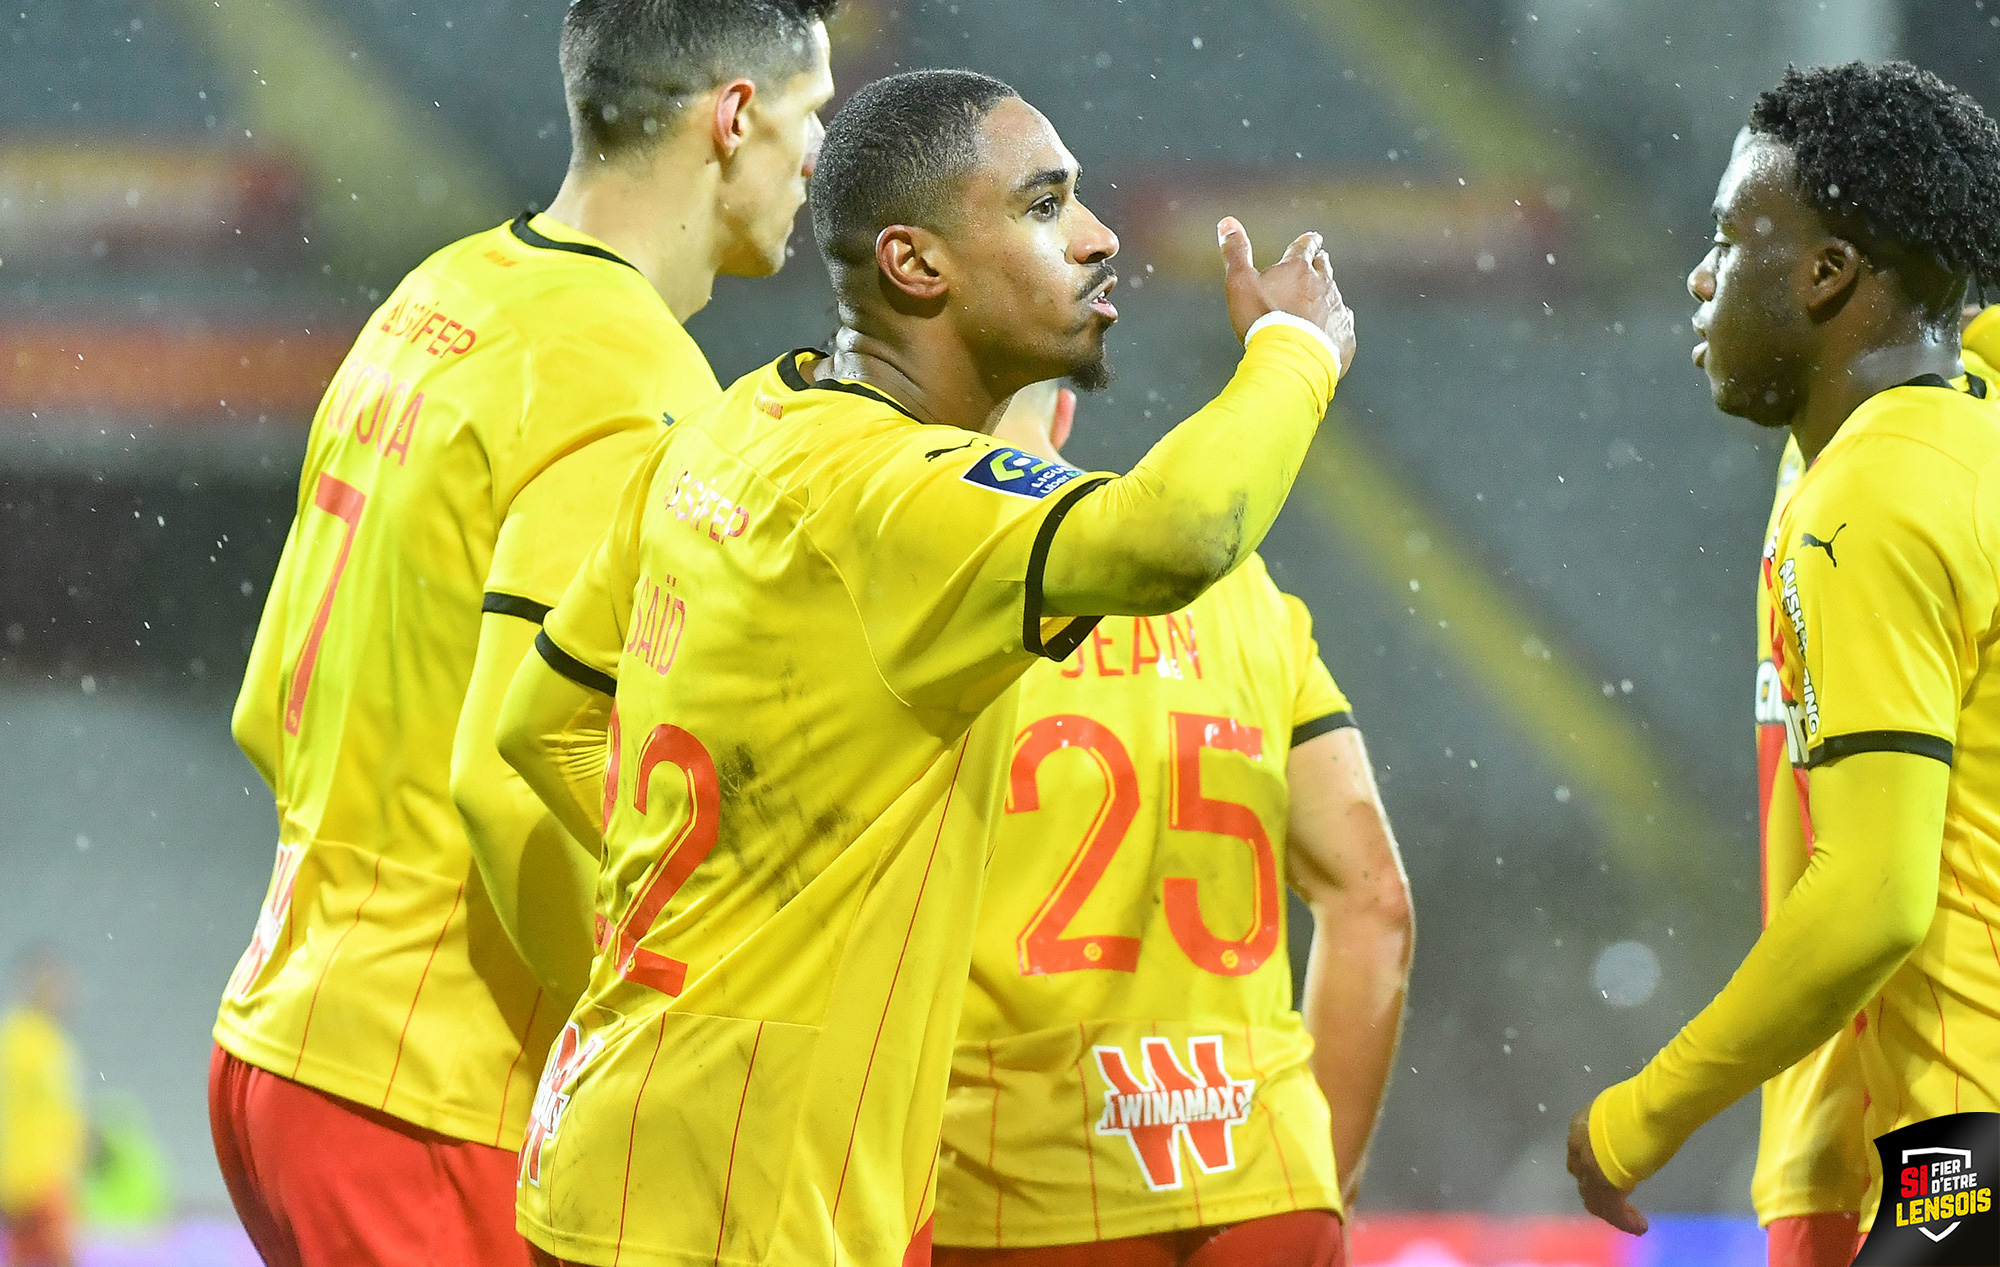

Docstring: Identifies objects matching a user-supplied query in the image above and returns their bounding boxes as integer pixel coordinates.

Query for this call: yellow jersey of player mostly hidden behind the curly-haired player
[1750,440,1870,1225]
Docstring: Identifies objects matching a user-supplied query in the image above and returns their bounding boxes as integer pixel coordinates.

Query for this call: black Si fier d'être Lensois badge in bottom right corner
[1854,1113,2000,1267]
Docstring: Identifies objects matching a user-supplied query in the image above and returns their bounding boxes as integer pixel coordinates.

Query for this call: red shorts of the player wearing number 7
[208,1047,530,1267]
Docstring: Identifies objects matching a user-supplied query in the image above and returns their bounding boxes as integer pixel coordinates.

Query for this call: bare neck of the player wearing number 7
[546,160,720,322]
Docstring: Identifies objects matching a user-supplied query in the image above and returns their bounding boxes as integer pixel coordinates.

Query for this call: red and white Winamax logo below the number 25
[1090,1035,1256,1193]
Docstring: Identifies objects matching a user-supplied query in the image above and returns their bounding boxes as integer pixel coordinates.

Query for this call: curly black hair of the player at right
[1750,62,2000,288]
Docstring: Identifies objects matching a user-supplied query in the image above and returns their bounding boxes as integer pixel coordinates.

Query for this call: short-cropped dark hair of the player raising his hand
[810,70,1020,275]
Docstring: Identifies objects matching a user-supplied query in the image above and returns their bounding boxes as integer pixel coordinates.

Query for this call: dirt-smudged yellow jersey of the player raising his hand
[518,352,1100,1265]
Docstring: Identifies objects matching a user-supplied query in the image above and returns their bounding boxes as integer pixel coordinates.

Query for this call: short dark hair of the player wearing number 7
[560,0,840,158]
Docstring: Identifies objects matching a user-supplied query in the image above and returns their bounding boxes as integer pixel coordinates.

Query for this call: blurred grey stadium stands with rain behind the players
[0,0,2000,1267]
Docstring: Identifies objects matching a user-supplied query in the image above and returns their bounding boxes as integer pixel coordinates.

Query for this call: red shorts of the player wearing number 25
[932,1209,1348,1267]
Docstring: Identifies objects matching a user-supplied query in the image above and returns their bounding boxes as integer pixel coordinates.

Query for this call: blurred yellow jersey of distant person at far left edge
[0,1007,88,1215]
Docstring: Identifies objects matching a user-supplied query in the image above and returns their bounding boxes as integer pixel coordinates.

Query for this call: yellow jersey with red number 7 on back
[216,216,720,1147]
